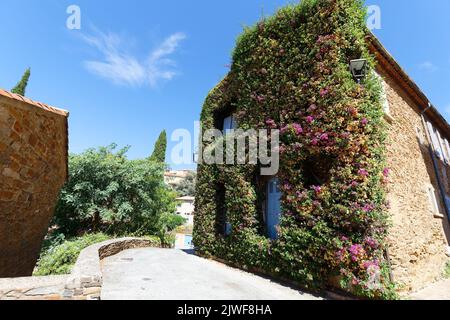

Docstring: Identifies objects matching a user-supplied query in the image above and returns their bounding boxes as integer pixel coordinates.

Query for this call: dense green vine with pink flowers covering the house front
[194,0,394,298]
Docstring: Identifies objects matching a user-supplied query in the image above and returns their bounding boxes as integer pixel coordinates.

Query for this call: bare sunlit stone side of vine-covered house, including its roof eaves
[367,35,450,290]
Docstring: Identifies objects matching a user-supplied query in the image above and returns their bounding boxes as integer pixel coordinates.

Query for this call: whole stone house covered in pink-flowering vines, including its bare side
[194,0,450,298]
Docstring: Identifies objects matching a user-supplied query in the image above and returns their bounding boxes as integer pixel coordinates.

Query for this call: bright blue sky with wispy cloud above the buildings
[0,0,450,169]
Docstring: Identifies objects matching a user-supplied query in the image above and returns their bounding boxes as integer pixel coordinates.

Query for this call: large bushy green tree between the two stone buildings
[54,144,181,238]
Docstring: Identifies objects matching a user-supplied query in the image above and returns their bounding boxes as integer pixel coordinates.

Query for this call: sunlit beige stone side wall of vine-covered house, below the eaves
[380,71,450,291]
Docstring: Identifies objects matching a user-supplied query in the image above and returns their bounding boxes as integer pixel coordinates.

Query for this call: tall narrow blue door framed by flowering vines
[267,178,281,239]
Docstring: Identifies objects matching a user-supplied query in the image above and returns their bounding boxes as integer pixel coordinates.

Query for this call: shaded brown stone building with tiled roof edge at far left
[0,90,69,278]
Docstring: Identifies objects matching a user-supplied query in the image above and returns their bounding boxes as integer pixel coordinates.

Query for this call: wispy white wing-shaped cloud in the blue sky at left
[82,31,186,87]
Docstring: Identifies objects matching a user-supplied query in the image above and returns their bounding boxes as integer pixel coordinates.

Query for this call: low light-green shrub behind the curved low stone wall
[34,233,110,276]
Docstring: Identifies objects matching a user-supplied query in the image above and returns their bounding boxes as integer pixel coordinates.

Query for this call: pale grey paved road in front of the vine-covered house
[101,249,320,300]
